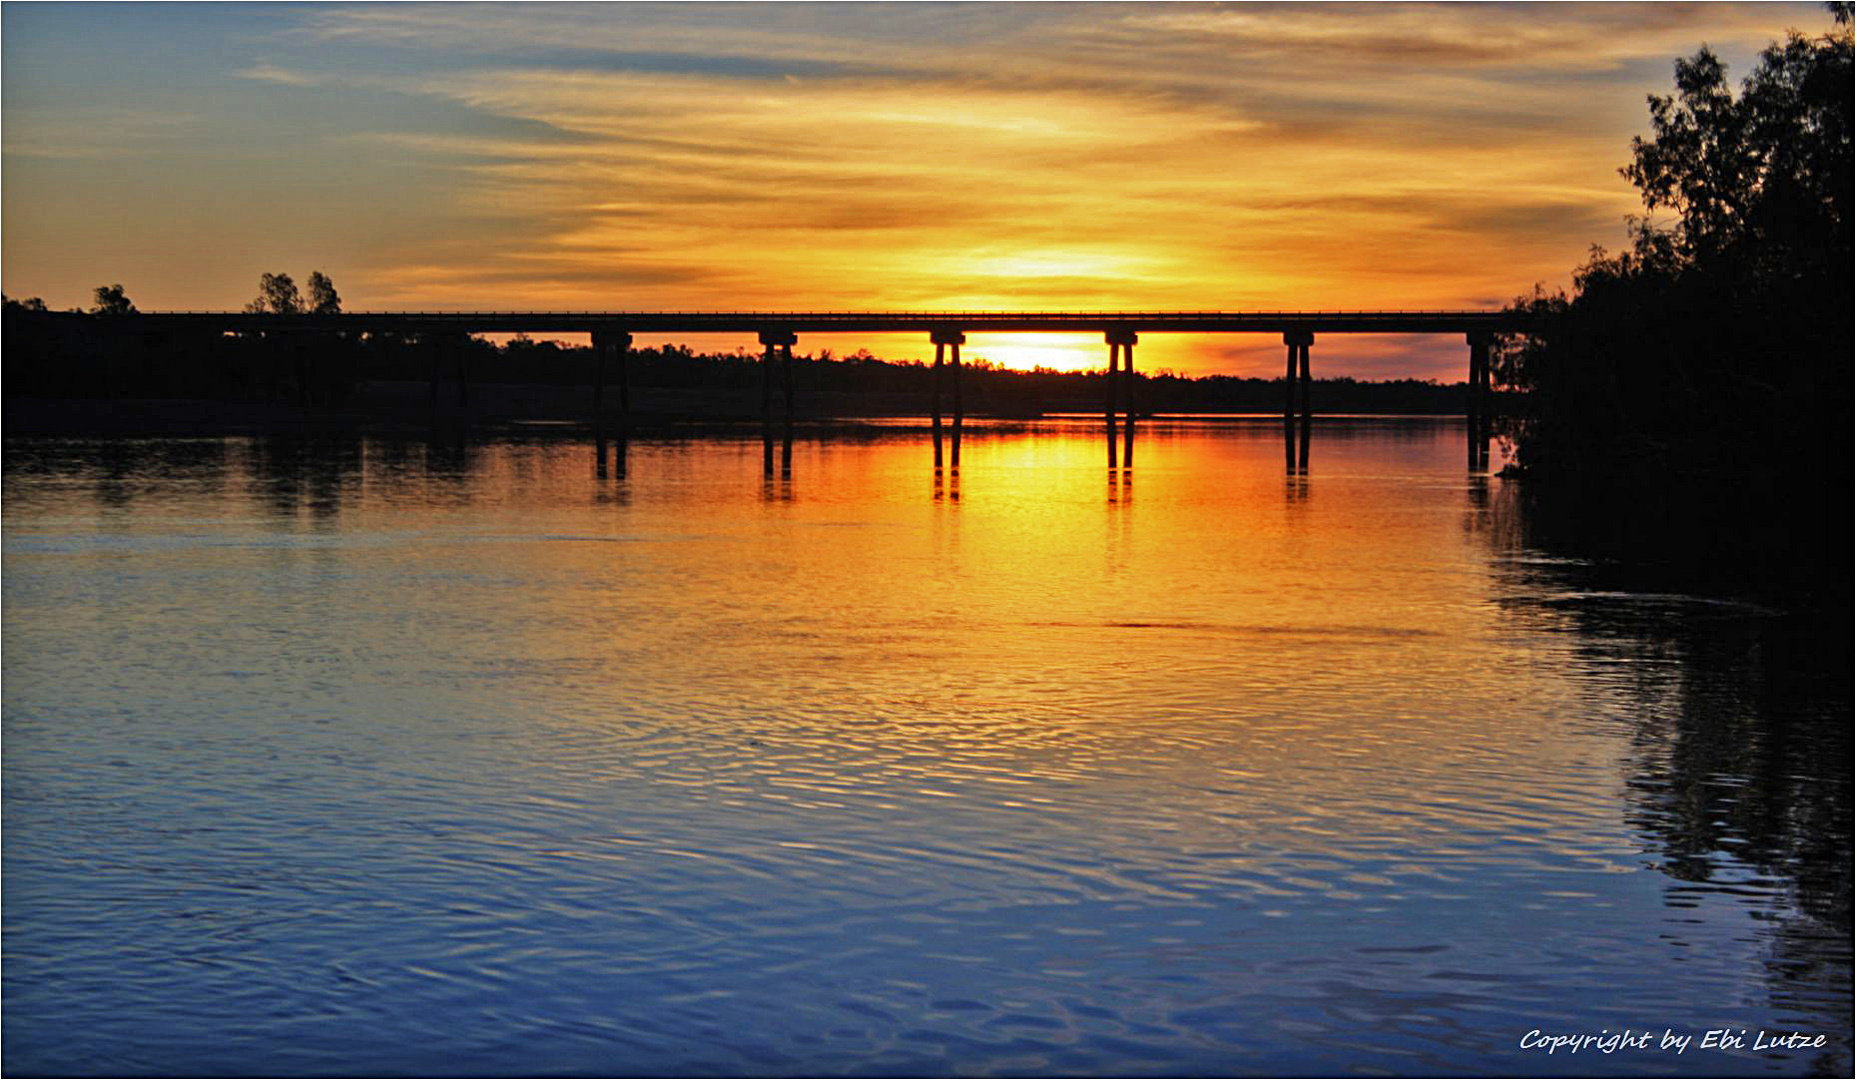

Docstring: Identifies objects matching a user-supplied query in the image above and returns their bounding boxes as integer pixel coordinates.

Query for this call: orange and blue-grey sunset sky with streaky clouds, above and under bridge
[0,4,1829,380]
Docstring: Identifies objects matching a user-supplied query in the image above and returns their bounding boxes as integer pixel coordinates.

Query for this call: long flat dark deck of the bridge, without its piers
[116,310,1510,334]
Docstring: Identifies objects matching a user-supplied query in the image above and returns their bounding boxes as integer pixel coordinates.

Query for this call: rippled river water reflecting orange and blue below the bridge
[4,421,1851,1074]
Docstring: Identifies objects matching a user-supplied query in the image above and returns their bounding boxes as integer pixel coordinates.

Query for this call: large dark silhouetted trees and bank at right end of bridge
[1493,4,1853,603]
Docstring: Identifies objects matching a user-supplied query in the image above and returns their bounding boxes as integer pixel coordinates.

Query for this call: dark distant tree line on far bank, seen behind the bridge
[4,271,1465,416]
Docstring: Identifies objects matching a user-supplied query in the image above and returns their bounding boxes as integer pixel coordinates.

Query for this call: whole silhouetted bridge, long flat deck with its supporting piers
[121,310,1519,468]
